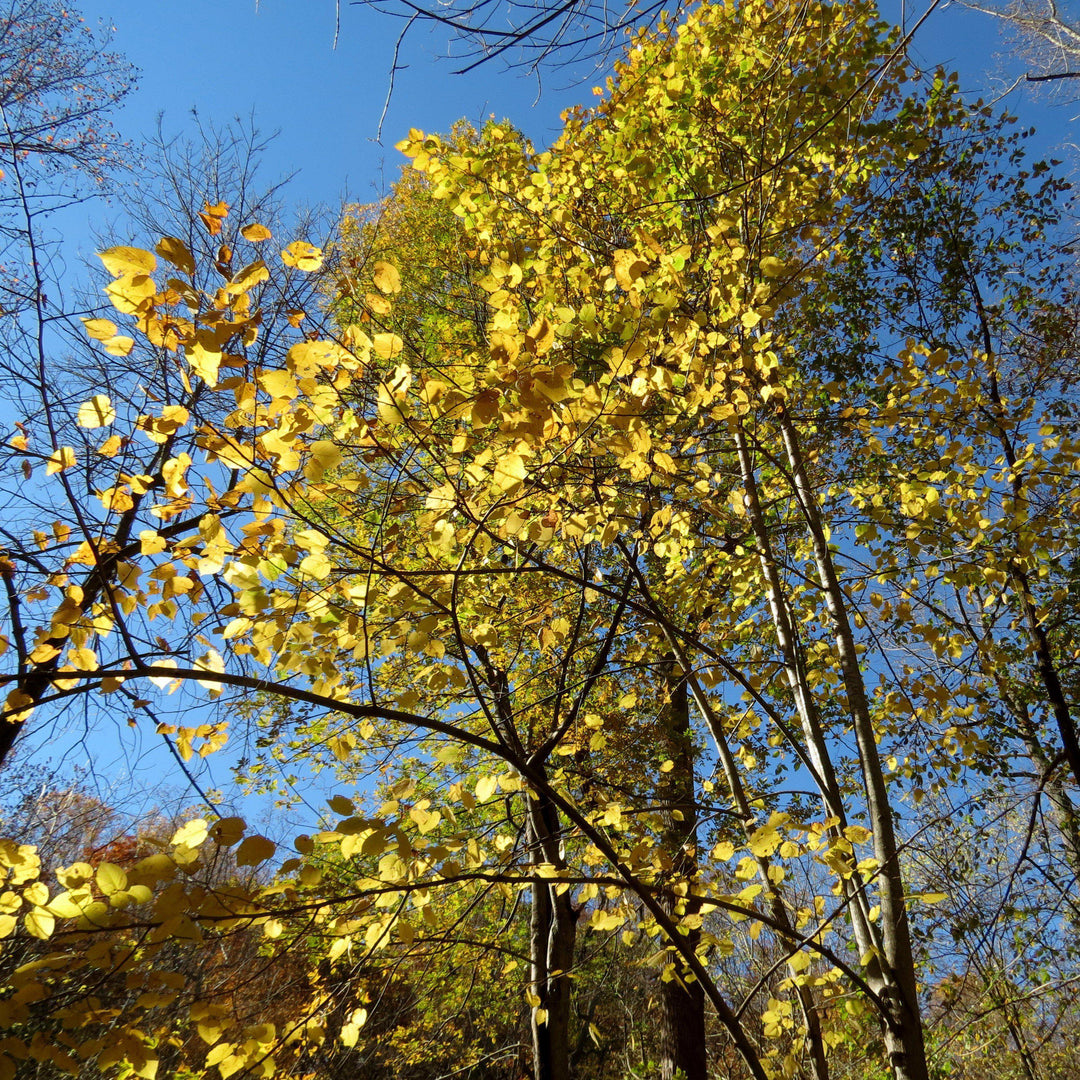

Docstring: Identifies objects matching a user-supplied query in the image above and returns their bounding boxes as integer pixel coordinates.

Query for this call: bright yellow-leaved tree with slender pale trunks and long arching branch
[0,0,1077,1080]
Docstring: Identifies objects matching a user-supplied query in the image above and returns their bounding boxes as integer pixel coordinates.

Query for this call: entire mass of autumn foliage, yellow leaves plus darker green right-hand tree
[0,0,1080,1080]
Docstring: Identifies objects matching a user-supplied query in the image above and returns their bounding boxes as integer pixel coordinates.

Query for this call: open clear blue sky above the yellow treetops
[82,0,1071,217]
